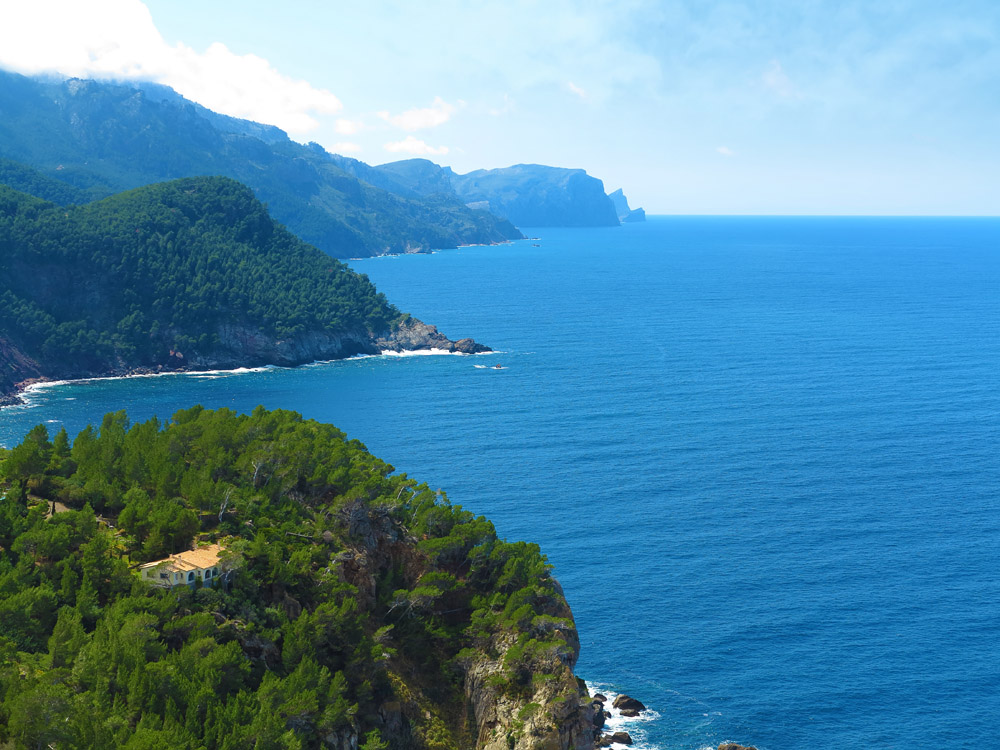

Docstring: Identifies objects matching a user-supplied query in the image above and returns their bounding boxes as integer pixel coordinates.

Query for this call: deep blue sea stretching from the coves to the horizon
[0,217,1000,750]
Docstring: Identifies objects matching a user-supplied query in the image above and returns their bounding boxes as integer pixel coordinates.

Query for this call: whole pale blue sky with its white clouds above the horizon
[0,0,1000,216]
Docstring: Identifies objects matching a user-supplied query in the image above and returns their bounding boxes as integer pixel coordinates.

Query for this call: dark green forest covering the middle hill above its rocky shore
[0,177,399,385]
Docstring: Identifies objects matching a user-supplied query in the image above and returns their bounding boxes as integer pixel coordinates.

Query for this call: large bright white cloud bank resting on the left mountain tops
[0,0,341,135]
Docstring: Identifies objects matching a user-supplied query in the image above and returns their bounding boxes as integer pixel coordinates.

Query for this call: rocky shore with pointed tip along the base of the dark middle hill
[0,316,492,407]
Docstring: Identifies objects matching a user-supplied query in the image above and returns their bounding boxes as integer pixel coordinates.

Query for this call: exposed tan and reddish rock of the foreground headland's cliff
[333,496,595,750]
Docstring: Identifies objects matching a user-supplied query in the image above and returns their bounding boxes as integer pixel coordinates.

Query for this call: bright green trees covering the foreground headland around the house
[0,407,576,750]
